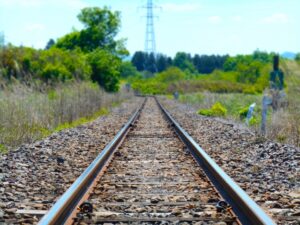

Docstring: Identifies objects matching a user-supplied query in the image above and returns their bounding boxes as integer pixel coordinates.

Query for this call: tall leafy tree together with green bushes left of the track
[0,7,129,92]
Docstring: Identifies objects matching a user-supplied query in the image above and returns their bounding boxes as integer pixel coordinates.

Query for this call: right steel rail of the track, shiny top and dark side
[155,97,275,225]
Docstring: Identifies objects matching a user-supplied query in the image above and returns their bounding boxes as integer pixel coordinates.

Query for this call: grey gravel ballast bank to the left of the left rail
[0,98,143,224]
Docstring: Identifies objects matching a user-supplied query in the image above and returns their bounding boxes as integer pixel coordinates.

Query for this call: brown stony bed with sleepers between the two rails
[77,98,237,225]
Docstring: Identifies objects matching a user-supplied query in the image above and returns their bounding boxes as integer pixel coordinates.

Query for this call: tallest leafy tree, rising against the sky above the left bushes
[57,7,128,56]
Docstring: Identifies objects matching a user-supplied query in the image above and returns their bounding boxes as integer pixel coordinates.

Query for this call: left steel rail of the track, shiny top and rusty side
[38,99,146,225]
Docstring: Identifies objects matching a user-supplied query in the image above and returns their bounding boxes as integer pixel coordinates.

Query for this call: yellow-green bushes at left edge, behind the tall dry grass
[0,46,91,82]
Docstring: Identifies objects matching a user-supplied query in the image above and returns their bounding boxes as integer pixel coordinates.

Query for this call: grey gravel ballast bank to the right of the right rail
[163,99,300,224]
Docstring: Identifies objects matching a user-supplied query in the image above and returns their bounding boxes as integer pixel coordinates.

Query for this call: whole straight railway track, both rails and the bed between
[39,98,274,225]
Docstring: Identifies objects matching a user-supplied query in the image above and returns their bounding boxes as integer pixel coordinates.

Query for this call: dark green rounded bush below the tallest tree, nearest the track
[88,49,121,92]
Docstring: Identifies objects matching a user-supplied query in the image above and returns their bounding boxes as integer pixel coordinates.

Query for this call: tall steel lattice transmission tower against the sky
[145,0,156,54]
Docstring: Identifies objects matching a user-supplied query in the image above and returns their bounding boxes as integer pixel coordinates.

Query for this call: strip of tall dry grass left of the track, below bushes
[0,82,131,151]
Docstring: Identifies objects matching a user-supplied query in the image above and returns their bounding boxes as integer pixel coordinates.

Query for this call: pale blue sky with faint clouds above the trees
[0,0,300,56]
